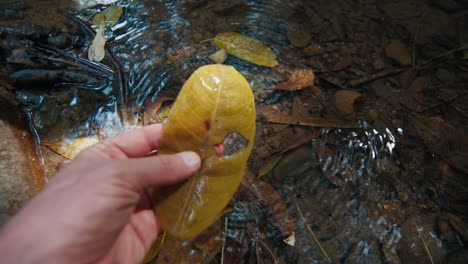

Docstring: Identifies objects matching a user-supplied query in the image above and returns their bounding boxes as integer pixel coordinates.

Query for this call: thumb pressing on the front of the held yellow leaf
[117,151,201,191]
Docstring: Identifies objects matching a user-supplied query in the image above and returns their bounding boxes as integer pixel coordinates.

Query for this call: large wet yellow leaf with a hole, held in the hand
[155,64,255,239]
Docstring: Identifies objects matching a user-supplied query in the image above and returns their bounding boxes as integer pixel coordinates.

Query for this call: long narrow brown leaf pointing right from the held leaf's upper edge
[261,111,359,128]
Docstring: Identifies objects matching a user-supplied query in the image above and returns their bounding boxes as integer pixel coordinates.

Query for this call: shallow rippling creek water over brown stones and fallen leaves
[0,0,468,263]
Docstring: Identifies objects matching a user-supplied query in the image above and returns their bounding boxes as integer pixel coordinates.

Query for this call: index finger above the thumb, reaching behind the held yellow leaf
[81,124,162,159]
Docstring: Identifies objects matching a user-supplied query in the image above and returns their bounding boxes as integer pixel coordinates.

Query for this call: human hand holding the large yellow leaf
[0,125,200,263]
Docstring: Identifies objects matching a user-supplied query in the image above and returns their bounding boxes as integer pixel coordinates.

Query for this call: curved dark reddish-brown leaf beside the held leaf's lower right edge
[241,170,296,246]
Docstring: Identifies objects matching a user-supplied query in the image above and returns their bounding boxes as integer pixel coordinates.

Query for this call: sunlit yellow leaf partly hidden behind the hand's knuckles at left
[41,137,99,159]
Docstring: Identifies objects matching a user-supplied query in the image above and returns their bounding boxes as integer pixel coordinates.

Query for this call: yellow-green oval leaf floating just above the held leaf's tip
[214,32,278,67]
